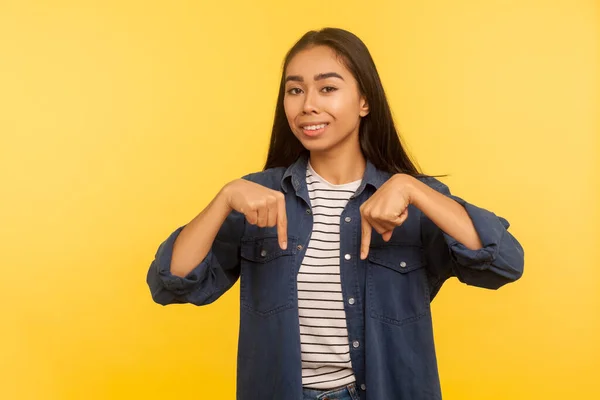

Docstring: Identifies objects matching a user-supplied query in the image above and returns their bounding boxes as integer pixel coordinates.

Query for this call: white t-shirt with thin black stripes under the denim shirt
[298,163,361,389]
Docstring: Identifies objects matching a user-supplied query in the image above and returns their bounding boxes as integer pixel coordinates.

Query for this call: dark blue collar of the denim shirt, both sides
[281,153,390,197]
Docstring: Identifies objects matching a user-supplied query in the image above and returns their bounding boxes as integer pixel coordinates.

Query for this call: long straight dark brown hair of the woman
[264,28,421,176]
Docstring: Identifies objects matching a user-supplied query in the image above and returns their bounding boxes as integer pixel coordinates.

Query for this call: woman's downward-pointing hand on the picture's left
[222,179,287,250]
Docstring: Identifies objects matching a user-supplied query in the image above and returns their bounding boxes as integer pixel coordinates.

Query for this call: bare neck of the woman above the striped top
[310,148,367,185]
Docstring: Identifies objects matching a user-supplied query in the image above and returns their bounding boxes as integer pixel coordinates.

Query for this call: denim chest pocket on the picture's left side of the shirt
[240,237,298,316]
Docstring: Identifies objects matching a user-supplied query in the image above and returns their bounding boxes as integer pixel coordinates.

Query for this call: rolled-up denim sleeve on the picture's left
[146,211,245,305]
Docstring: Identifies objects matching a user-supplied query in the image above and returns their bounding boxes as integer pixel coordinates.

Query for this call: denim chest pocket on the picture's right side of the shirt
[367,245,430,325]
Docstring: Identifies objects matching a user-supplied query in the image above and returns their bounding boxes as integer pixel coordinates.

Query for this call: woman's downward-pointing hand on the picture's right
[360,174,414,260]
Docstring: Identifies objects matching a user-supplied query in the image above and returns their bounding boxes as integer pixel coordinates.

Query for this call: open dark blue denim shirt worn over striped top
[147,156,524,400]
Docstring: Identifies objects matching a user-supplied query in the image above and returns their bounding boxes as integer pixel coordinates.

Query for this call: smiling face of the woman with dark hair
[283,46,369,152]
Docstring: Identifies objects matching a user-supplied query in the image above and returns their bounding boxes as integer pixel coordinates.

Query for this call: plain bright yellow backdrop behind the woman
[0,0,600,400]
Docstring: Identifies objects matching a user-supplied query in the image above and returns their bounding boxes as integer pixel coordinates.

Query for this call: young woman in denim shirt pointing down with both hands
[147,28,523,400]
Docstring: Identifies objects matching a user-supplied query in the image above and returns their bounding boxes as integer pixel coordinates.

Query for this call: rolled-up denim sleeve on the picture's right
[421,179,524,295]
